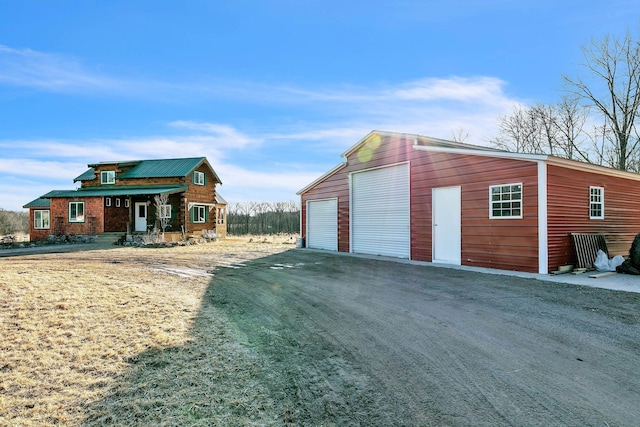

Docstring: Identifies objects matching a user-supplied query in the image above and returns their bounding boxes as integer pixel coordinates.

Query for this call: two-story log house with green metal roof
[24,157,226,241]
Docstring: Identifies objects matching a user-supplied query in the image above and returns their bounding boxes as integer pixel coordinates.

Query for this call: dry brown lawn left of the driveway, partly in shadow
[0,237,292,426]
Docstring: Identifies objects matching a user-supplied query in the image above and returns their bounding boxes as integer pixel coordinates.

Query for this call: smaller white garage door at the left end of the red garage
[306,199,338,251]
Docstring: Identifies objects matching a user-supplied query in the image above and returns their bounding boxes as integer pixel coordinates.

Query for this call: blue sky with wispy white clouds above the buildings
[0,0,640,210]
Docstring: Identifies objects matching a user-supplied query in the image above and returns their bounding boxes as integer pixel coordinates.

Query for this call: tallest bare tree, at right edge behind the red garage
[563,32,640,170]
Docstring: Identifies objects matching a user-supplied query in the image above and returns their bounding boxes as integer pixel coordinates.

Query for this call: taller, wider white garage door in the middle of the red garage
[351,163,411,258]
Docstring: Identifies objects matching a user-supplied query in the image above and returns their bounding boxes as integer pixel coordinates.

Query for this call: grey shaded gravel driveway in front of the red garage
[211,250,640,426]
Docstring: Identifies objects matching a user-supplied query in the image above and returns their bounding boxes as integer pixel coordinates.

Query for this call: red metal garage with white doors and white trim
[298,131,640,273]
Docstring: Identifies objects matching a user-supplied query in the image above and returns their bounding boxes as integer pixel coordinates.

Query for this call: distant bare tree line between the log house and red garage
[227,201,300,236]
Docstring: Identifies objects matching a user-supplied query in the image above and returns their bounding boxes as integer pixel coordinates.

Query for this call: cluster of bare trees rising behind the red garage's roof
[490,31,640,173]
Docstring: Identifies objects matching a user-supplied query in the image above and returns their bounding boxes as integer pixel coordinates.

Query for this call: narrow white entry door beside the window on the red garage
[432,187,462,265]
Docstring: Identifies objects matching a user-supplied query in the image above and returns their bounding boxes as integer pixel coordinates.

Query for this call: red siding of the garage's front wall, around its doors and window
[302,137,538,272]
